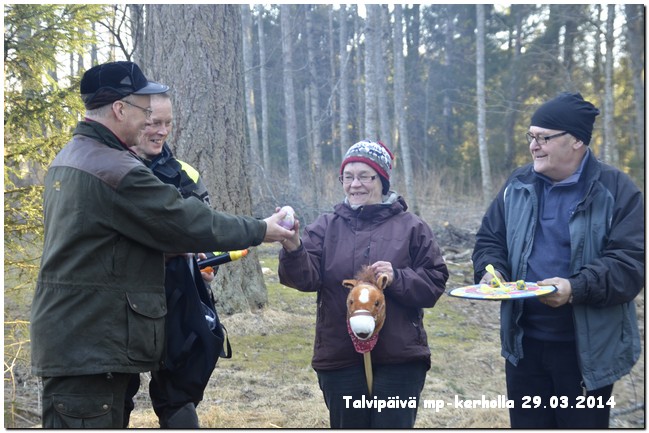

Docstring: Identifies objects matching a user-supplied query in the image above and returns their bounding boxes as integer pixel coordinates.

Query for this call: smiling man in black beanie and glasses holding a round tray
[473,93,645,429]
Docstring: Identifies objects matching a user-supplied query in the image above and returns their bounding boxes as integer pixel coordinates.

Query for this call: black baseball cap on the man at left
[80,61,169,110]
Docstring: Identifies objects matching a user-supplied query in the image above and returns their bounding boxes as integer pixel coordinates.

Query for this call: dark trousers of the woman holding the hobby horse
[317,362,428,429]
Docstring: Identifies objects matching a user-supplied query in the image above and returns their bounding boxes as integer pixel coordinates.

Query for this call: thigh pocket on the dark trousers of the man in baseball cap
[52,394,113,428]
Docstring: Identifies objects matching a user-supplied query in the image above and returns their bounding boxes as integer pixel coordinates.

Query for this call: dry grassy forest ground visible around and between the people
[4,193,645,428]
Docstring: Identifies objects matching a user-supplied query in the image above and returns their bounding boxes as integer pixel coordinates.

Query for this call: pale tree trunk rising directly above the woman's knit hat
[364,4,380,140]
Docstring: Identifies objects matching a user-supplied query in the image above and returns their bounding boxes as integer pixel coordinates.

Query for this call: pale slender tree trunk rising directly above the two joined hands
[279,4,300,199]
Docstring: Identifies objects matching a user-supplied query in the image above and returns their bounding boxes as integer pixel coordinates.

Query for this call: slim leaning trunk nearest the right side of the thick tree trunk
[241,4,262,172]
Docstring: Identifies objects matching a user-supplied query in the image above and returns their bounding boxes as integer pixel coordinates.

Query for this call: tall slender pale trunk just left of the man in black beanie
[476,4,492,206]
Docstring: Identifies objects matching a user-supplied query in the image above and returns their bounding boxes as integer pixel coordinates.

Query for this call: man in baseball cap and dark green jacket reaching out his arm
[31,62,294,428]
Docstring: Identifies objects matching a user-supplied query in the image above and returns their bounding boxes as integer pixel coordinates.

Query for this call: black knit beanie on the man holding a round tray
[530,93,599,145]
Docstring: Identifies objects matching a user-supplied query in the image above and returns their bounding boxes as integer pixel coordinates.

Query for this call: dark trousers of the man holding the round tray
[505,337,613,429]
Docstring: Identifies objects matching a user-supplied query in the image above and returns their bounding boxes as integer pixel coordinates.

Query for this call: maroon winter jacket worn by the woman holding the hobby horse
[279,194,448,370]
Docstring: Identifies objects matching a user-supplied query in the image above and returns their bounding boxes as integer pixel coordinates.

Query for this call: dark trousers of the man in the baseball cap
[42,373,132,429]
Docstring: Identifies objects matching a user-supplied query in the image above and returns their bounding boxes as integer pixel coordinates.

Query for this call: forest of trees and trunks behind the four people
[4,4,645,428]
